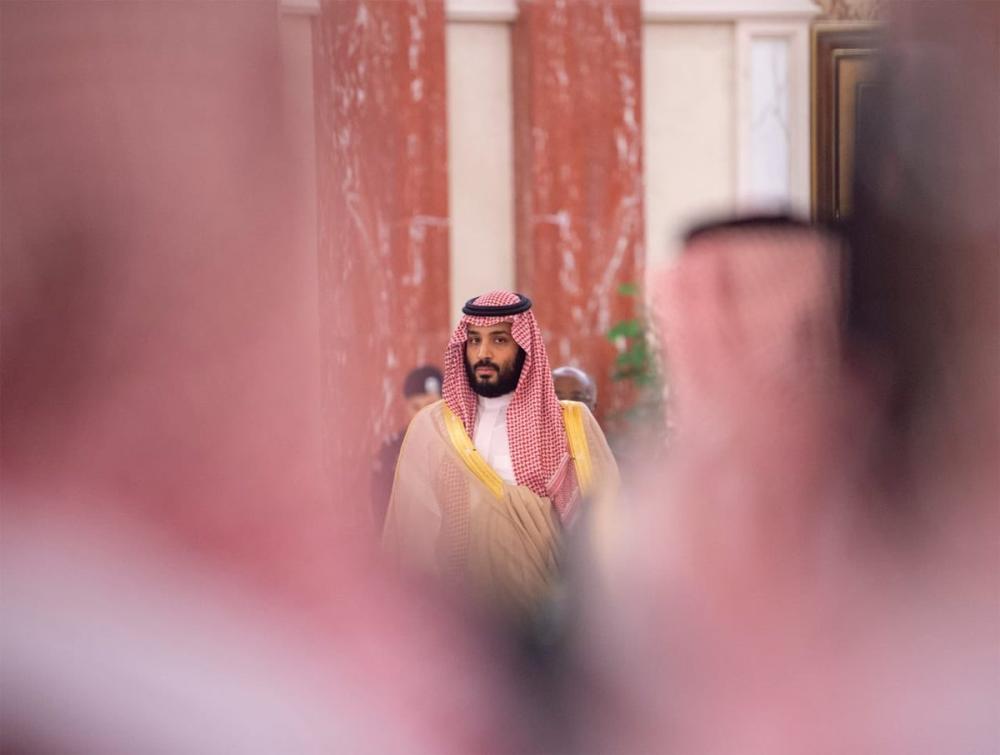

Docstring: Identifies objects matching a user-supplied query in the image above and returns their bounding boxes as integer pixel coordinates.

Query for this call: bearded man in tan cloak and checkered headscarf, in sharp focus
[383,291,618,615]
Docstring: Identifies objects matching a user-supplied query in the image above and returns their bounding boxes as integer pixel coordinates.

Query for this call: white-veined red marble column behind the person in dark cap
[314,0,449,522]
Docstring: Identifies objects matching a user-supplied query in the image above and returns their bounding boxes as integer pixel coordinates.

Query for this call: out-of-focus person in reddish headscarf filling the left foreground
[0,0,517,753]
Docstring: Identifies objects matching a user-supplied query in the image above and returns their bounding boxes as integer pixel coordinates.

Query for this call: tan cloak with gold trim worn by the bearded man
[382,401,618,615]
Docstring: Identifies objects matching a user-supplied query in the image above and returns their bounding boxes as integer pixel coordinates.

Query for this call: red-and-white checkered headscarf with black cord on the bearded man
[444,291,576,520]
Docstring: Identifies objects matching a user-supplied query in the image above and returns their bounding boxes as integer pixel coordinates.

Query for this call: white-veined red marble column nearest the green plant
[513,0,643,426]
